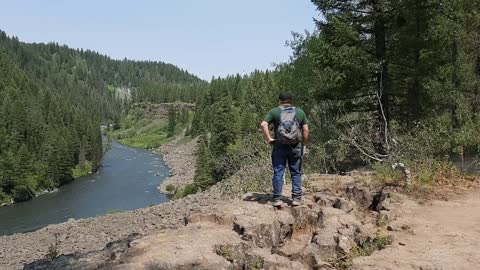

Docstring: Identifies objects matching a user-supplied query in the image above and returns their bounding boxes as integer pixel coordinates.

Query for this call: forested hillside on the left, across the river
[0,31,201,203]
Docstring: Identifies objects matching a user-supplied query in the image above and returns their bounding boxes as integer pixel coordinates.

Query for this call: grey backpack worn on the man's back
[276,107,302,145]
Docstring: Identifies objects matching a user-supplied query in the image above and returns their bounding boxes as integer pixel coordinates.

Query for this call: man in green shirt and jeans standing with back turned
[261,92,308,207]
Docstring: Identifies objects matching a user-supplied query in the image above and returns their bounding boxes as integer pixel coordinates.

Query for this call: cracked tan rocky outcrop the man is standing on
[24,188,390,270]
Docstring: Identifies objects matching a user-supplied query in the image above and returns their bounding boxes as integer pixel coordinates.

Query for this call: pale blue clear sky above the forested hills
[0,0,318,80]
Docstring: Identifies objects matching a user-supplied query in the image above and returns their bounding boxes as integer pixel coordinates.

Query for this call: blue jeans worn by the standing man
[272,144,303,199]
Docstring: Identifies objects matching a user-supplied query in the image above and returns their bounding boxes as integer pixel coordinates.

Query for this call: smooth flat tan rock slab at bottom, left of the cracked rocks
[111,224,248,270]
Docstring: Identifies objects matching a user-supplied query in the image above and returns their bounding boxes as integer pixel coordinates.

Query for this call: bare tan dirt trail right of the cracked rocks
[352,191,480,270]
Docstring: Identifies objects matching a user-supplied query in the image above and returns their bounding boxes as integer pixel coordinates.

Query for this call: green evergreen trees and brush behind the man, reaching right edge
[189,0,480,194]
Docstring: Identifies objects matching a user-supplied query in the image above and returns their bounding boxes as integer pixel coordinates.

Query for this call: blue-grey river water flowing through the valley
[0,141,169,235]
